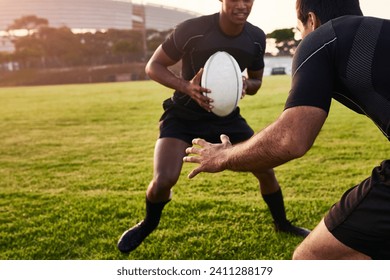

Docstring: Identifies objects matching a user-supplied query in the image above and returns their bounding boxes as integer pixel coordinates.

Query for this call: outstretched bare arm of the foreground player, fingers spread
[184,106,327,178]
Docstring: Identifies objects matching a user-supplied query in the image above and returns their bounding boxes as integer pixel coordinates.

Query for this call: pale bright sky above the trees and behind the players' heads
[142,0,390,33]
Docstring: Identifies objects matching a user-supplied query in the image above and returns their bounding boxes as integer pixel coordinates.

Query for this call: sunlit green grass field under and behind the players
[0,76,389,260]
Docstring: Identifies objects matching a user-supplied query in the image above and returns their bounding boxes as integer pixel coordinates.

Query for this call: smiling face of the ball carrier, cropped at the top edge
[220,0,254,24]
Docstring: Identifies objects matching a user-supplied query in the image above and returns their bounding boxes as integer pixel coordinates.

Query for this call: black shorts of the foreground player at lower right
[324,160,390,260]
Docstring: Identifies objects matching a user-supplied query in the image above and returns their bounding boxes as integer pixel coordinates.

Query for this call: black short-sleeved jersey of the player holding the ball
[162,13,265,115]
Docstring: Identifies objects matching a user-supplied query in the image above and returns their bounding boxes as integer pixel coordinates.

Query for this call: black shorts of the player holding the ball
[159,101,254,144]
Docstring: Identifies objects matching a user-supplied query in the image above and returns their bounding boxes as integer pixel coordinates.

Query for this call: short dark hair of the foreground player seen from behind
[296,0,363,24]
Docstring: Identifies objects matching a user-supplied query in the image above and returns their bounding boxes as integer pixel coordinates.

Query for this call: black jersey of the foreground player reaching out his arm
[285,16,390,140]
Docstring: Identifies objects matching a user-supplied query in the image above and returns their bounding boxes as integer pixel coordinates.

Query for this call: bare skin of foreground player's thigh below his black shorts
[293,219,371,260]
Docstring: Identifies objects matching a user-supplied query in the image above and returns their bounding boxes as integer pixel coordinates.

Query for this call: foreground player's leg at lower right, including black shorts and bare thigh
[294,160,390,260]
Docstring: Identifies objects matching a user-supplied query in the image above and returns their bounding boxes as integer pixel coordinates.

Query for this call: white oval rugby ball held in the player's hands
[201,51,242,117]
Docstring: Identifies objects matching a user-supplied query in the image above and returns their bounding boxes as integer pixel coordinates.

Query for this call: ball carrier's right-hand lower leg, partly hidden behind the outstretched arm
[253,169,310,237]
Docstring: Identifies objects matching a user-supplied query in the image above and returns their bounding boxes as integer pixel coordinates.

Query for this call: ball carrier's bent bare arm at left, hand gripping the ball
[145,45,212,111]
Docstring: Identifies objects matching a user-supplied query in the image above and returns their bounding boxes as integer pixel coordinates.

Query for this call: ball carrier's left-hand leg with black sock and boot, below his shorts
[118,138,189,253]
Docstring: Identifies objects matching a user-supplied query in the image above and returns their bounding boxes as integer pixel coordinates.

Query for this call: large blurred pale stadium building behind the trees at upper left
[0,0,199,51]
